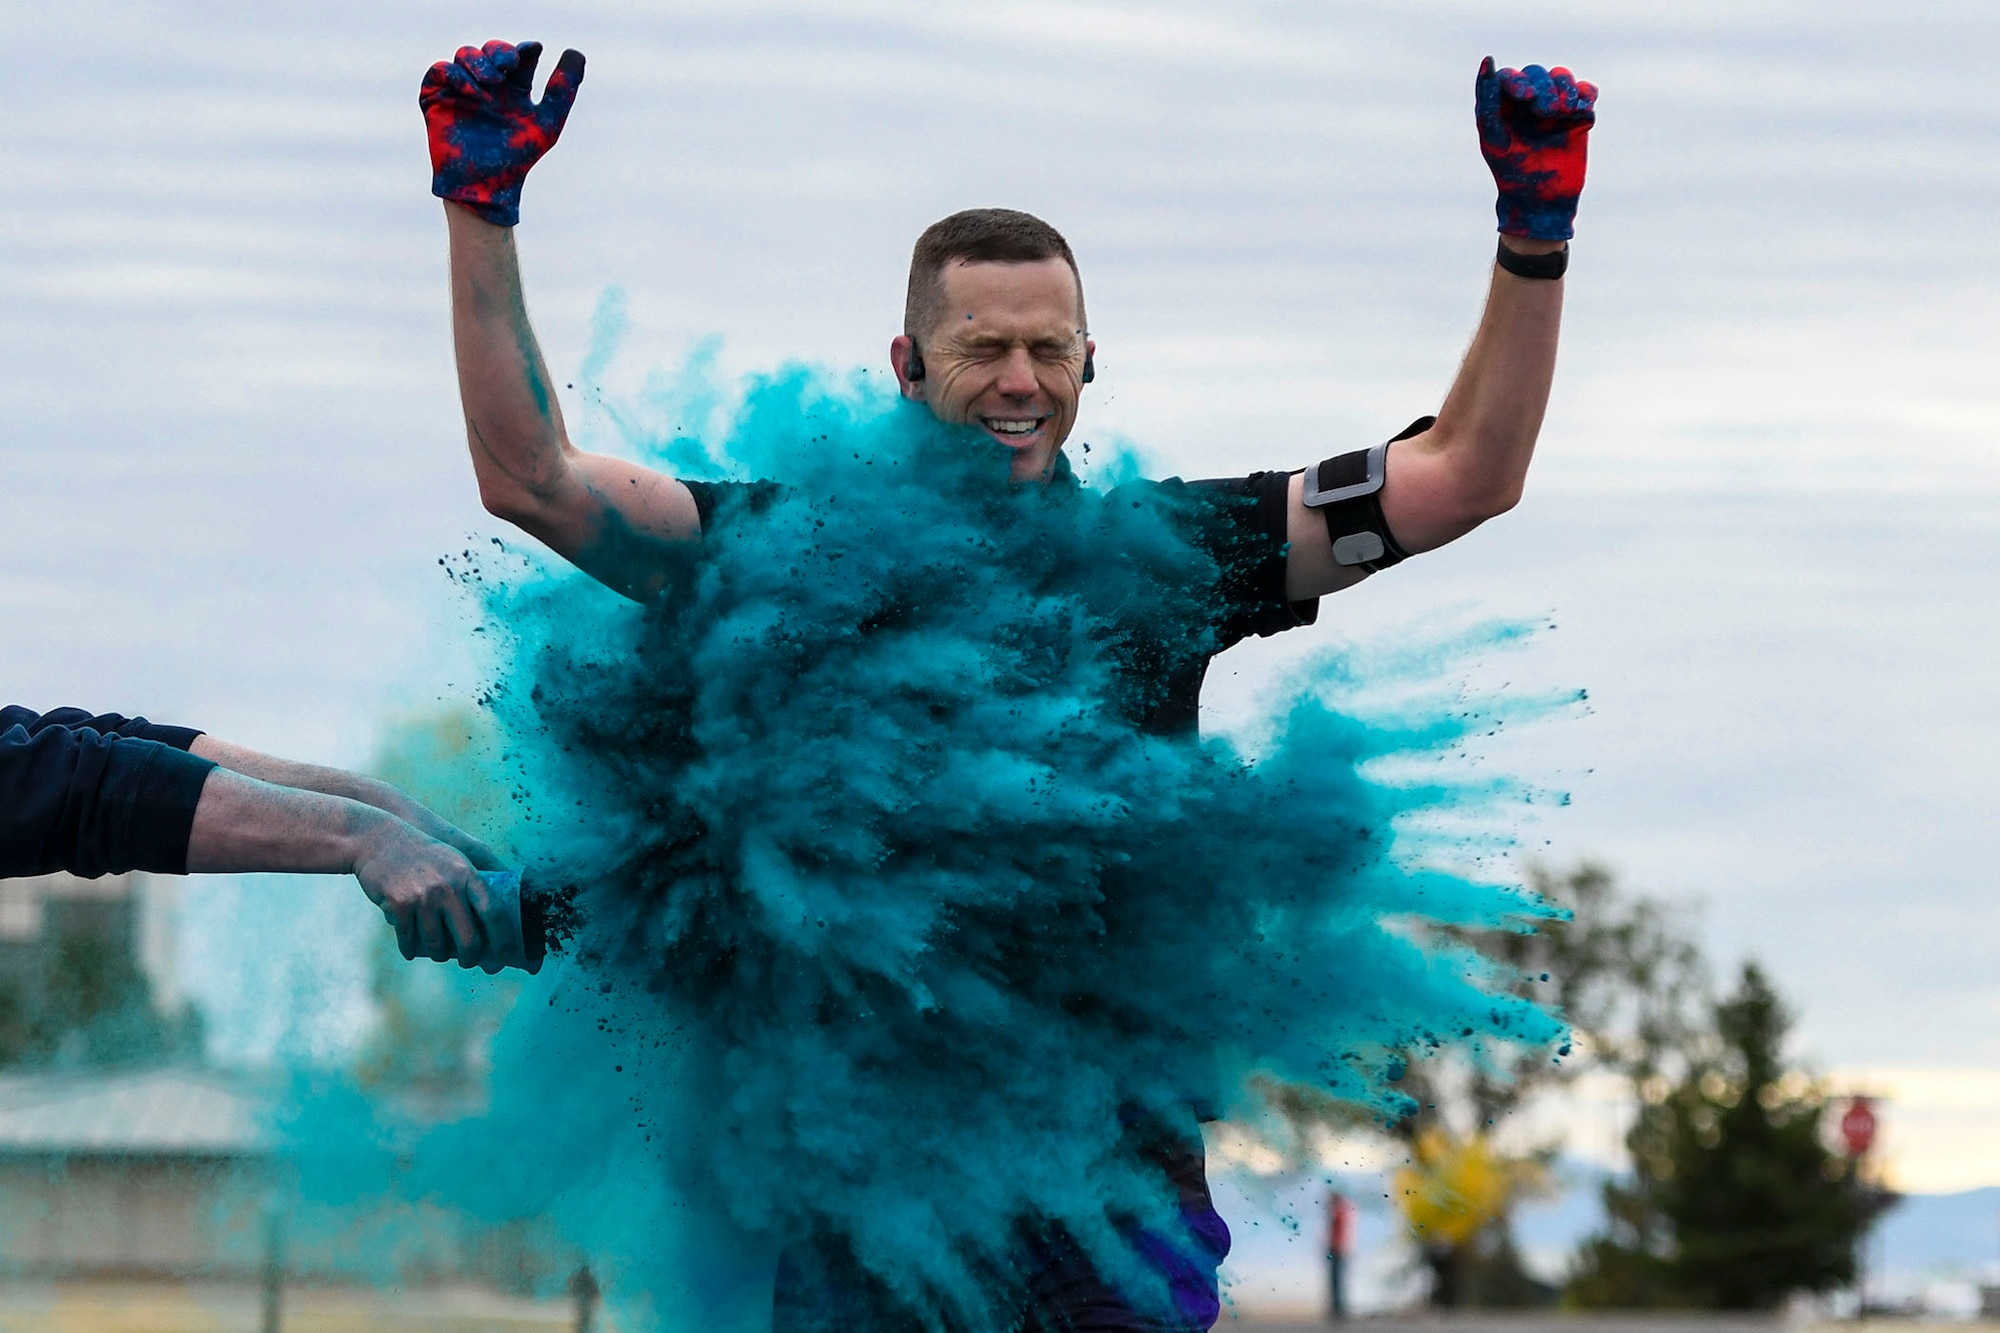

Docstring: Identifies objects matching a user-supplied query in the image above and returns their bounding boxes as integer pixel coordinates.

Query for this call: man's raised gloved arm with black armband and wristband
[1286,60,1598,600]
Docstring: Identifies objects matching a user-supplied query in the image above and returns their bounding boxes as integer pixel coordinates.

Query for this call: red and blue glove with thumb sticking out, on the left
[416,42,584,226]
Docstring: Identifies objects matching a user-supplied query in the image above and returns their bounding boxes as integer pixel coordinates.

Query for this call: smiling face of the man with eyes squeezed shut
[890,258,1094,480]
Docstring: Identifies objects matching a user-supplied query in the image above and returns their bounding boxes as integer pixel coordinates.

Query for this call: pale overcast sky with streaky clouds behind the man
[0,0,2000,1187]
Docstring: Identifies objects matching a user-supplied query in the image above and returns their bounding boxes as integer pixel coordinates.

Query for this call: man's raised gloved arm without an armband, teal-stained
[420,42,700,600]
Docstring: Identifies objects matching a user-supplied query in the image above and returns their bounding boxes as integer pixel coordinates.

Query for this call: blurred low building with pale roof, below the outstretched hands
[0,1067,564,1295]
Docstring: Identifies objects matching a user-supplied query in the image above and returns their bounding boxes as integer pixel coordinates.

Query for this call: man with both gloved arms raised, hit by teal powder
[420,42,1596,1333]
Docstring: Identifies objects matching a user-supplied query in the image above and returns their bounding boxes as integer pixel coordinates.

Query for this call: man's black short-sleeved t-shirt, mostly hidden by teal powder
[682,464,1320,735]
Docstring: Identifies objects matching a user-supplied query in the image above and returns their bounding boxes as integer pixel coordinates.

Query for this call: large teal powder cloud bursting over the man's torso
[278,344,1562,1329]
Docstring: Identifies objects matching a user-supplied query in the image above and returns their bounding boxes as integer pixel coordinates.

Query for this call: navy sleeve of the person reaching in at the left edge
[0,707,214,879]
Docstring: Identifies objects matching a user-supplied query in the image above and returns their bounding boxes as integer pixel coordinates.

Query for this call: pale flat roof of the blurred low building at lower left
[0,1067,272,1157]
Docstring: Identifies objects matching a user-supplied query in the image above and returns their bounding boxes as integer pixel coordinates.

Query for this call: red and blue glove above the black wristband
[1474,56,1598,240]
